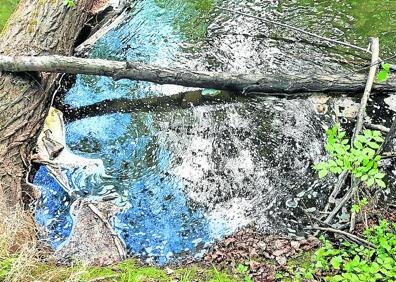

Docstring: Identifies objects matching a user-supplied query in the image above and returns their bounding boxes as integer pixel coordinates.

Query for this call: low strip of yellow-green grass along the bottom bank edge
[0,259,243,282]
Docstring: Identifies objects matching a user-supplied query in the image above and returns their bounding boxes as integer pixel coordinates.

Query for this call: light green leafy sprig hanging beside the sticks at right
[313,124,386,188]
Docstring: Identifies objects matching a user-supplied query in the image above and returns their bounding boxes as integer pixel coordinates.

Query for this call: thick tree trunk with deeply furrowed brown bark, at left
[0,0,95,206]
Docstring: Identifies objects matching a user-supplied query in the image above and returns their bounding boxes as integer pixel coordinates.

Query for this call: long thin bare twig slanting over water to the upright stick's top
[217,7,370,53]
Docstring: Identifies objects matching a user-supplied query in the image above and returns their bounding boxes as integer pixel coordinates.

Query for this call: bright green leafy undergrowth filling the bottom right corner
[294,220,396,282]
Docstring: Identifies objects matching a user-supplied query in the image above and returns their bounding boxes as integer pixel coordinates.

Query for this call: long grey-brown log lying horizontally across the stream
[0,56,396,94]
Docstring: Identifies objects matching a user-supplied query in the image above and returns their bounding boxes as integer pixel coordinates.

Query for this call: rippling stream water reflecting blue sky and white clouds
[35,0,396,264]
